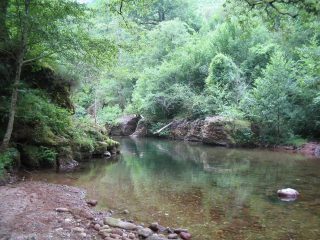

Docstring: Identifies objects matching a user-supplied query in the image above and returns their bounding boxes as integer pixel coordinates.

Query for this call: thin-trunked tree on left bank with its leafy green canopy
[0,0,114,149]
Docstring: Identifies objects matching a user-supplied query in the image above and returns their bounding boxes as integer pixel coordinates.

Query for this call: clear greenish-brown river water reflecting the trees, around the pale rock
[32,138,320,240]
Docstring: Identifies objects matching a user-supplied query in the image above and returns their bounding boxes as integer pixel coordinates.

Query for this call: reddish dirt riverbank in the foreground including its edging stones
[0,181,190,240]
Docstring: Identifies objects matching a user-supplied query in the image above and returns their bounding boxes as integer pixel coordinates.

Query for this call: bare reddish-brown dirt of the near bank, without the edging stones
[0,182,97,239]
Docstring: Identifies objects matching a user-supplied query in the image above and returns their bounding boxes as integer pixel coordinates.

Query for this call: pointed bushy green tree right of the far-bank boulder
[245,51,298,144]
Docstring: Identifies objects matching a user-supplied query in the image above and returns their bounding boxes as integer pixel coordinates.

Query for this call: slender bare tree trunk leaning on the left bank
[0,0,30,151]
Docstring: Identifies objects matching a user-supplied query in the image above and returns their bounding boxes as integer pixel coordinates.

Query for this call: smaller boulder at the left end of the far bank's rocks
[106,115,141,136]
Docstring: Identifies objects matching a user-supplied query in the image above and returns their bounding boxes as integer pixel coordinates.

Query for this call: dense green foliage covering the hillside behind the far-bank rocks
[68,0,320,144]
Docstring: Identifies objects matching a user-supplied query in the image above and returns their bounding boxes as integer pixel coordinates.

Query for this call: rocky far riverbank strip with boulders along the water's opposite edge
[106,115,320,158]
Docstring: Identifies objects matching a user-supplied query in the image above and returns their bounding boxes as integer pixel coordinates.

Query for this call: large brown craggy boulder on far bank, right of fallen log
[168,116,251,146]
